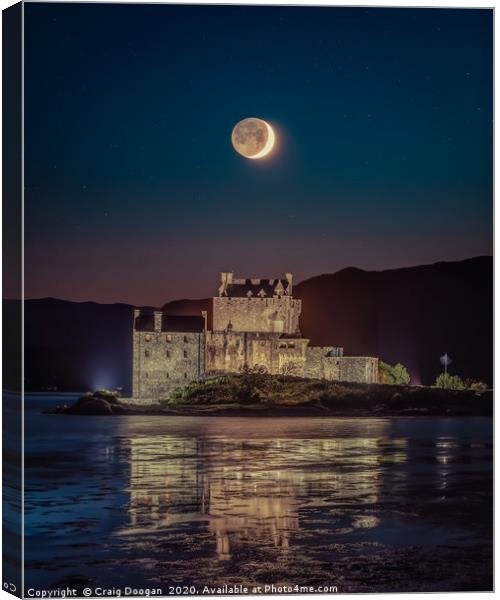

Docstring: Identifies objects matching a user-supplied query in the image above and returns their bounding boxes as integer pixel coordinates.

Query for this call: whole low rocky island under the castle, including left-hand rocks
[46,373,493,417]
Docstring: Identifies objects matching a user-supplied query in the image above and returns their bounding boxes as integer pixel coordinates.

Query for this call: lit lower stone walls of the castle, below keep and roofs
[133,324,378,402]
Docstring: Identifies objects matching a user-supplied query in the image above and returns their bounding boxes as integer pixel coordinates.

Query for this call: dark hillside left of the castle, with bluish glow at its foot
[3,298,143,391]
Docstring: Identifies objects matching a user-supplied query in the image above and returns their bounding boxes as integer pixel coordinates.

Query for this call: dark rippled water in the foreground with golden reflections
[20,397,492,593]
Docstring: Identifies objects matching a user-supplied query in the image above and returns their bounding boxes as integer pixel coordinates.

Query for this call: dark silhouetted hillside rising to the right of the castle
[294,256,493,383]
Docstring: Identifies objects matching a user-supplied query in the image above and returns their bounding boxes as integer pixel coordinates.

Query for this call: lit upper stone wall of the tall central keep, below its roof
[212,296,301,334]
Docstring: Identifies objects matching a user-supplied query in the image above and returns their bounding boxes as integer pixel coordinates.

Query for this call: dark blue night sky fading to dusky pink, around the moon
[25,4,493,305]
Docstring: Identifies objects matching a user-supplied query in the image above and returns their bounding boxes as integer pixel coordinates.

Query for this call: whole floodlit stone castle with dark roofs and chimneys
[132,273,378,402]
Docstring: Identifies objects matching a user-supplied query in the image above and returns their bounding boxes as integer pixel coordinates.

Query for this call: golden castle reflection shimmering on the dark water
[115,421,407,560]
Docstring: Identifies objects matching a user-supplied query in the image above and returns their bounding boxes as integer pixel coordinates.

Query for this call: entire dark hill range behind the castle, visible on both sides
[4,257,493,392]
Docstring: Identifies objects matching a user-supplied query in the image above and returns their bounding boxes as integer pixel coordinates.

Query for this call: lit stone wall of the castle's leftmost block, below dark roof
[132,331,205,401]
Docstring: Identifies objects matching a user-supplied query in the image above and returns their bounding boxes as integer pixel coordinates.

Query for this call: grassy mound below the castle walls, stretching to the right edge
[160,372,491,414]
